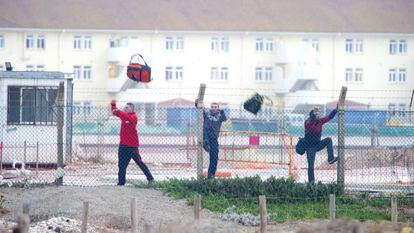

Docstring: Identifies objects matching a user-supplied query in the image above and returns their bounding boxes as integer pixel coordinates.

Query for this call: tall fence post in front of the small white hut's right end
[56,82,65,185]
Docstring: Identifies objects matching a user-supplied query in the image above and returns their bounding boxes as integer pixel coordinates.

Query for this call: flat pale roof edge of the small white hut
[0,71,66,79]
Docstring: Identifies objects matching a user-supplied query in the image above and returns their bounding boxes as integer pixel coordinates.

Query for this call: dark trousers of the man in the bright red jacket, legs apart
[118,145,154,185]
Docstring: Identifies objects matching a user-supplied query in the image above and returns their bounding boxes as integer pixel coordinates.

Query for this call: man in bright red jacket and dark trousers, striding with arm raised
[111,100,154,185]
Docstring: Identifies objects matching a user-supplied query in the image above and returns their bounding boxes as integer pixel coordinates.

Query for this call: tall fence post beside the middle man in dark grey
[197,83,206,180]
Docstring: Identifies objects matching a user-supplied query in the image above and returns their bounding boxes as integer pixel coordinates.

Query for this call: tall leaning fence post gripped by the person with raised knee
[337,86,348,190]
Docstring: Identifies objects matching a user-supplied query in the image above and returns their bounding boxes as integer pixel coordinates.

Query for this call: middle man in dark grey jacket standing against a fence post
[195,100,227,178]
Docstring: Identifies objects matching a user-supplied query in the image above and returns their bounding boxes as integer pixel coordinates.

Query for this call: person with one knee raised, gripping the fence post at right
[305,107,338,183]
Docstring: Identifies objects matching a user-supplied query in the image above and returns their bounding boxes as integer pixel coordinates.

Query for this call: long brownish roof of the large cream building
[0,0,414,33]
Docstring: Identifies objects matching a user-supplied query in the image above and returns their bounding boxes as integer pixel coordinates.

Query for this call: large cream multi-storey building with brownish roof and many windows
[0,0,414,114]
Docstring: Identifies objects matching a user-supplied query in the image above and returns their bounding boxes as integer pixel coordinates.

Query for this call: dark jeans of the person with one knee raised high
[306,138,334,183]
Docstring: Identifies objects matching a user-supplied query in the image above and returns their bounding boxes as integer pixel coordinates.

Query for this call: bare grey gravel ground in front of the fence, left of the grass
[0,186,246,232]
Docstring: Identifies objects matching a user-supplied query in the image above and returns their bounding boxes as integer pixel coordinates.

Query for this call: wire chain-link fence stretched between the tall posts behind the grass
[0,104,414,192]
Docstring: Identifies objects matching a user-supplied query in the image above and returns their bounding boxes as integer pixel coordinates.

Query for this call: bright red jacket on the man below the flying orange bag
[111,103,139,146]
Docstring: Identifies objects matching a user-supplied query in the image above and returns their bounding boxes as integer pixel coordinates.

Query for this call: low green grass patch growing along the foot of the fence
[136,177,414,222]
